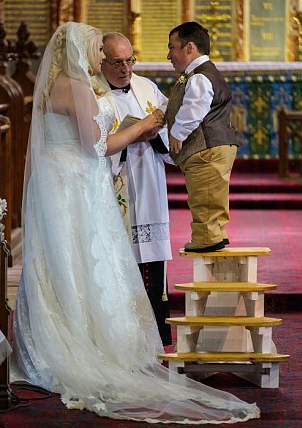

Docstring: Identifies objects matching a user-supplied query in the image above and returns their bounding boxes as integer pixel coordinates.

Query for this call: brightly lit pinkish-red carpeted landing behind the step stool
[168,209,302,294]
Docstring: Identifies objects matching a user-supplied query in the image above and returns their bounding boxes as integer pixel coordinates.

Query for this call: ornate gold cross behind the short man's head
[197,1,230,61]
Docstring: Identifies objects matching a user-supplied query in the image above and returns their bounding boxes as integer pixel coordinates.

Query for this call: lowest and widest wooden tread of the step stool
[157,352,290,363]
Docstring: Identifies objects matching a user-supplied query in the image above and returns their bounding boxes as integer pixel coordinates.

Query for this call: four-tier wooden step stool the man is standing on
[158,247,289,388]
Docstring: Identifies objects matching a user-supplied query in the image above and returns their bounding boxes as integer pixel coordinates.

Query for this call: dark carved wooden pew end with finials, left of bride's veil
[0,22,36,228]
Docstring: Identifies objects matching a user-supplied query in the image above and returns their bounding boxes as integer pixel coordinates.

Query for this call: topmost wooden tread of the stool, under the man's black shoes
[179,247,271,257]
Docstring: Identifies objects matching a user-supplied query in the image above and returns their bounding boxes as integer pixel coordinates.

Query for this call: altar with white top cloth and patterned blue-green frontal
[134,61,302,159]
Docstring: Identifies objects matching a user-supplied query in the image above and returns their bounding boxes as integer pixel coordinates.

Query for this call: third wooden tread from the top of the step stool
[166,316,282,327]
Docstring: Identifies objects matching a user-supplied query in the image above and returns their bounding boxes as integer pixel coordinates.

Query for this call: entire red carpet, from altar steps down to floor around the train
[0,166,302,428]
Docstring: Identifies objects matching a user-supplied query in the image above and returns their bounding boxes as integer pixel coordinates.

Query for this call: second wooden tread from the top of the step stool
[174,282,277,293]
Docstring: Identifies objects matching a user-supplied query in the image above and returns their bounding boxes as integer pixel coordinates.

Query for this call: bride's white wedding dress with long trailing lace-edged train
[11,98,259,424]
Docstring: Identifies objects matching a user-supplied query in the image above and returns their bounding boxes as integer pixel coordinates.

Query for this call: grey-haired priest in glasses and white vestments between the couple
[97,32,172,346]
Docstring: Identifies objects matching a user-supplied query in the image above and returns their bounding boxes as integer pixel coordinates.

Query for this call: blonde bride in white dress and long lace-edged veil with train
[11,22,259,424]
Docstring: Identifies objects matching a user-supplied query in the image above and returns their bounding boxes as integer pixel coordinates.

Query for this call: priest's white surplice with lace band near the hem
[98,74,172,263]
